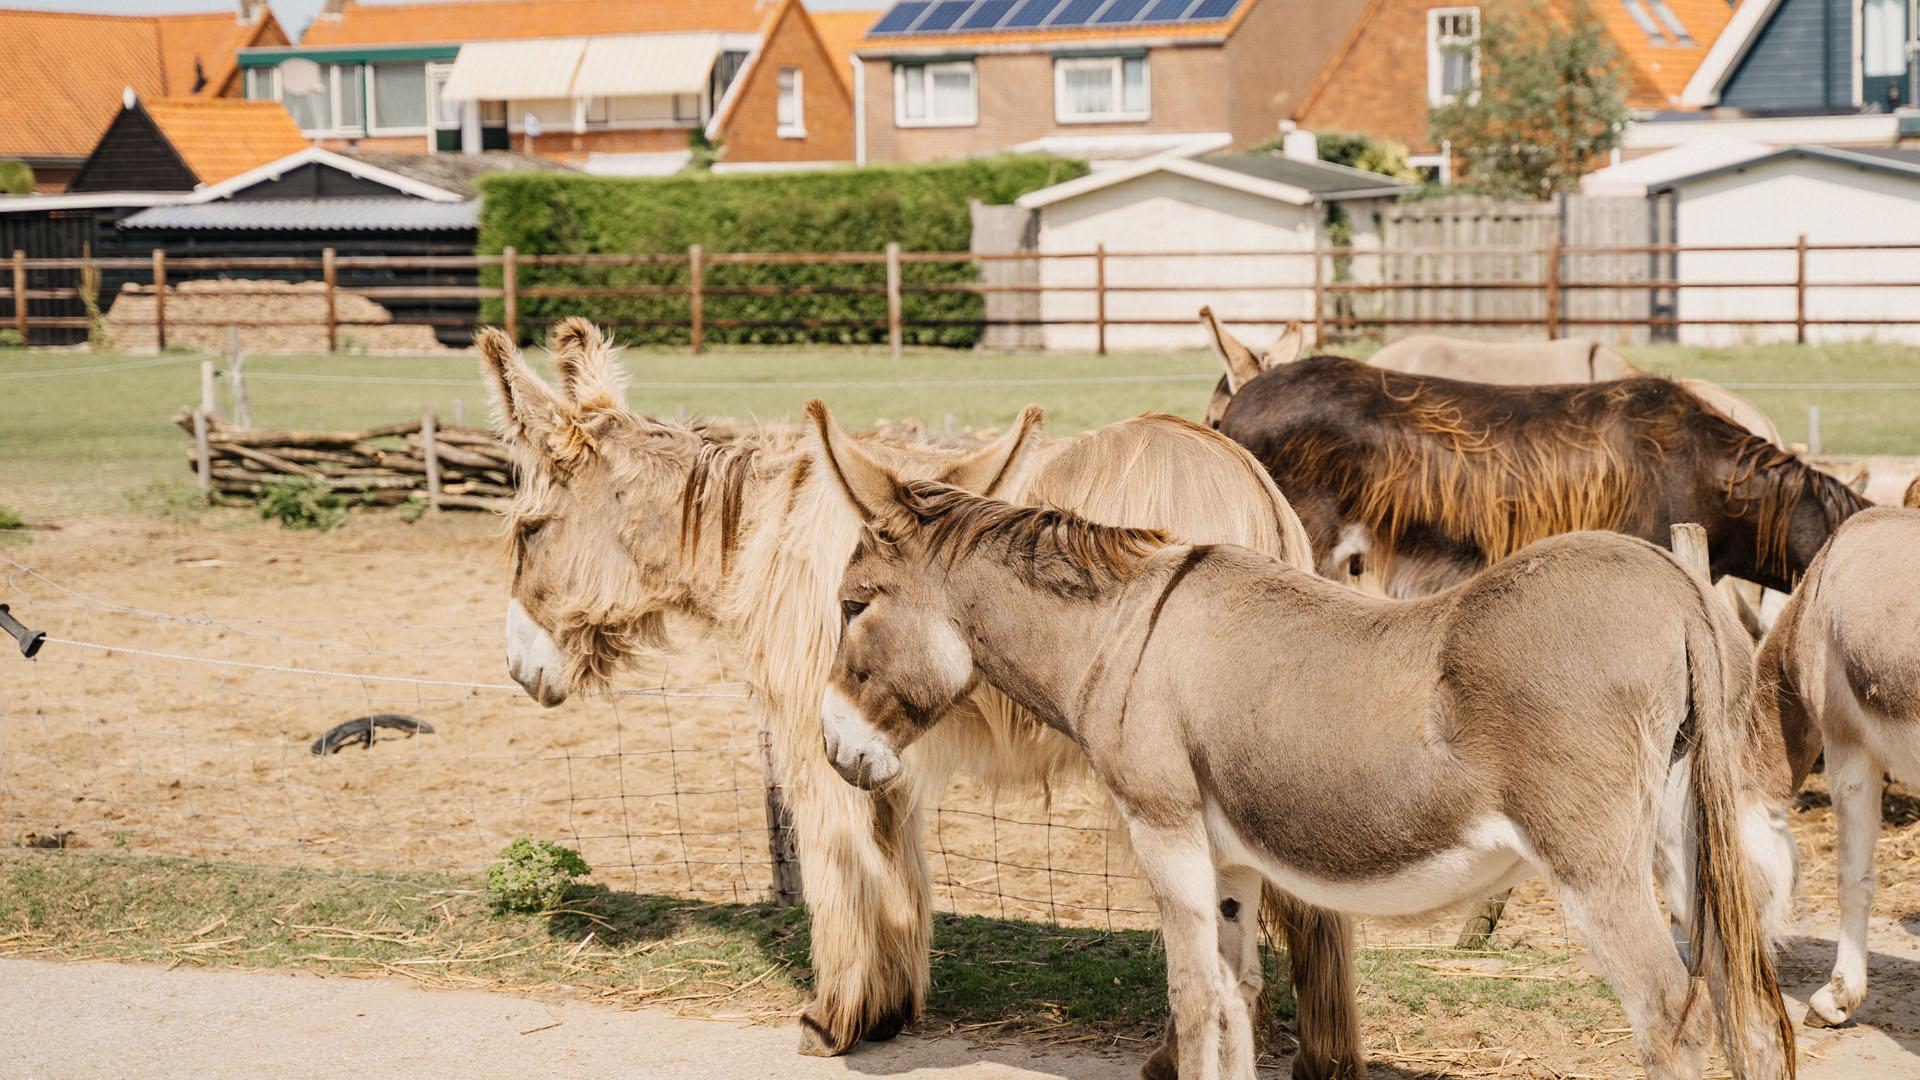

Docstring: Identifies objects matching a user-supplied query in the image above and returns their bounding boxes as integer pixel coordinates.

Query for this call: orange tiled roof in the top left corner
[0,8,286,158]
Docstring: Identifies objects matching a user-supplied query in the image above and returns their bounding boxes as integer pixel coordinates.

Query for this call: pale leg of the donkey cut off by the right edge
[1807,740,1882,1028]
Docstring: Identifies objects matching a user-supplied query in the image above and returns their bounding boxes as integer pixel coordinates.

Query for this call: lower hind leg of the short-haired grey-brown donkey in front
[1561,878,1713,1080]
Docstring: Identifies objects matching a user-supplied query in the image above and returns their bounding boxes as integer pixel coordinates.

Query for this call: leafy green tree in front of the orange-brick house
[1430,0,1626,198]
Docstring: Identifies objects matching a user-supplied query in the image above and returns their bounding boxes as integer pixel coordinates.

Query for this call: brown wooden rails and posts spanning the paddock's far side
[11,236,1920,356]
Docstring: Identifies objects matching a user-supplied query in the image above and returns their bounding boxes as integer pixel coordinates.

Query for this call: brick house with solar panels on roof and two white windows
[854,0,1363,161]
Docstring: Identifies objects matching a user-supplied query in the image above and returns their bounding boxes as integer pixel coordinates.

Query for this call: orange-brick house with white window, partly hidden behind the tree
[1292,0,1732,173]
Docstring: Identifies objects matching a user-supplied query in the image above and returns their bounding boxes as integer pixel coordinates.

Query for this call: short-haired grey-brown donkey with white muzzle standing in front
[808,402,1793,1080]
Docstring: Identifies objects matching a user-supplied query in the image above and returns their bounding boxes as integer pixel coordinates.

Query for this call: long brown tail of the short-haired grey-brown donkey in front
[1686,607,1795,1080]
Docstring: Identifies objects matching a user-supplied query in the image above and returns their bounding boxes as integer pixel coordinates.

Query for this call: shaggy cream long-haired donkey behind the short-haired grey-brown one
[478,319,1363,1078]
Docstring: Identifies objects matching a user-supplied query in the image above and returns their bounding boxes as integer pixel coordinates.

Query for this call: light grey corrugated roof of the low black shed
[119,198,480,233]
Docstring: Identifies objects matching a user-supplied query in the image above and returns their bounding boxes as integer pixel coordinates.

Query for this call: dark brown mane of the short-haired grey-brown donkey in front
[881,480,1175,596]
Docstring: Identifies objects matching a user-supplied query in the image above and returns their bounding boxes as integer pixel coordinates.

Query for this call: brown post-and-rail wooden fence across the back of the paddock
[0,236,1920,356]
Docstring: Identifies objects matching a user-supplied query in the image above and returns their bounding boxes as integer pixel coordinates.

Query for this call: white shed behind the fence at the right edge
[1647,146,1920,344]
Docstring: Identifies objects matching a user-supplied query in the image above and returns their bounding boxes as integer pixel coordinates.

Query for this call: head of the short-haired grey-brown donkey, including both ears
[806,400,1041,788]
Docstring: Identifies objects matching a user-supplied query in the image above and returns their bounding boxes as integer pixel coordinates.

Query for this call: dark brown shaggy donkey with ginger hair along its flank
[1208,315,1868,596]
